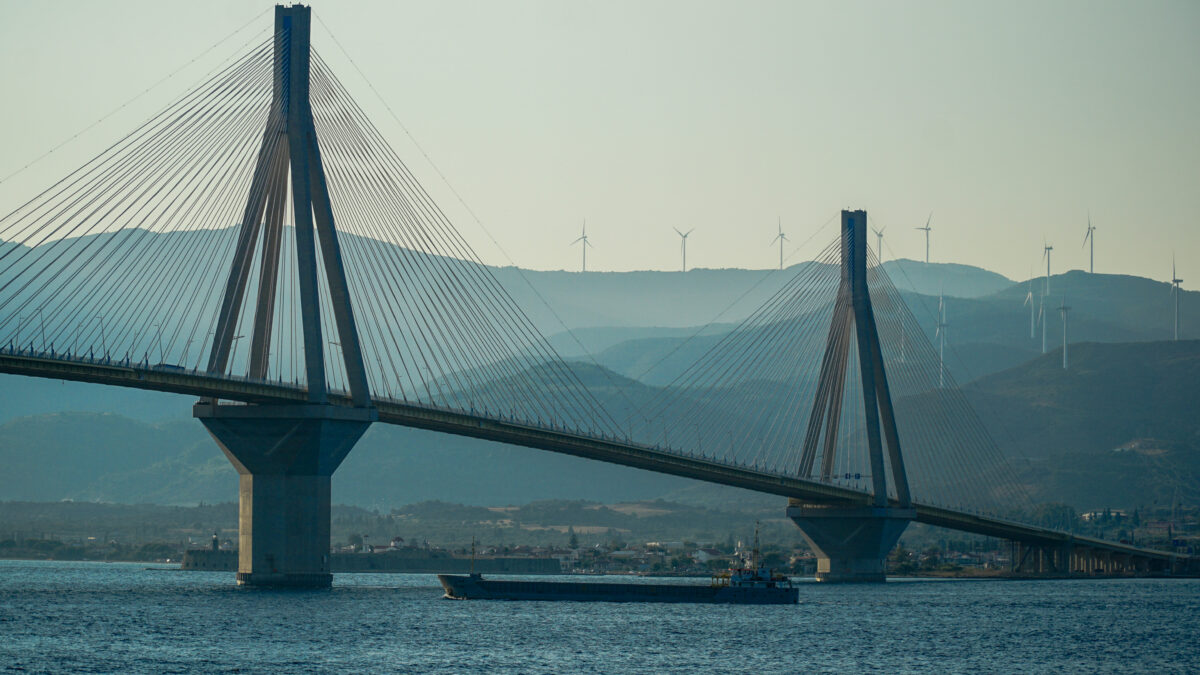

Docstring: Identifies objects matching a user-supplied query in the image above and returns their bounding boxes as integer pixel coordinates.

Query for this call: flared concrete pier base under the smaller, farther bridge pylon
[787,502,917,584]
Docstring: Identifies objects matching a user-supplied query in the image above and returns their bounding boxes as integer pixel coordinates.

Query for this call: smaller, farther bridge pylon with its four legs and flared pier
[787,211,917,583]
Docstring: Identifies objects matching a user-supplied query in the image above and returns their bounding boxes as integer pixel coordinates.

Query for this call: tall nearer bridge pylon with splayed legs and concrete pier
[192,5,378,587]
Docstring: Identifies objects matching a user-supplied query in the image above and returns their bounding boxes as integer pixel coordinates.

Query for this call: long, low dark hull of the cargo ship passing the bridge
[438,574,799,604]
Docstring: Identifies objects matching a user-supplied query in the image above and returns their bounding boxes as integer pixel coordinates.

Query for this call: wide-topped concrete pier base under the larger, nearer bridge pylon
[192,401,377,589]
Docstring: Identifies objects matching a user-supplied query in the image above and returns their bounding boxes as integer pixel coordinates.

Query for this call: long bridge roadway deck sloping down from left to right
[0,347,1200,569]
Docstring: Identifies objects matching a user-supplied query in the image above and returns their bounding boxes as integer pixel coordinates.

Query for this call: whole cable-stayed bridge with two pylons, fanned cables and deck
[0,6,1195,586]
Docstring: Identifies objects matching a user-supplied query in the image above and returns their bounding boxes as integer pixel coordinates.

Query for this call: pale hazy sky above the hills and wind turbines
[0,0,1200,278]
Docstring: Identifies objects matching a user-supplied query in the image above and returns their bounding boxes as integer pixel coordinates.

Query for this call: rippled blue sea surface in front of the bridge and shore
[0,561,1200,673]
